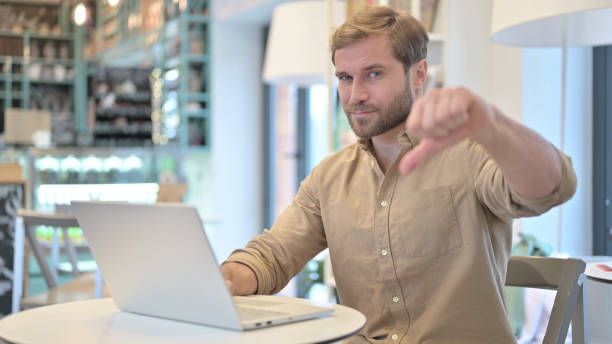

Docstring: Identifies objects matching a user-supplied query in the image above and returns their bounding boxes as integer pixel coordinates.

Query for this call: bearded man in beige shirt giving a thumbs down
[221,7,576,344]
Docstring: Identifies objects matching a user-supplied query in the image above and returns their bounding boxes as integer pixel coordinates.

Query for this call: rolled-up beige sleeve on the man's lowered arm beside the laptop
[225,168,327,294]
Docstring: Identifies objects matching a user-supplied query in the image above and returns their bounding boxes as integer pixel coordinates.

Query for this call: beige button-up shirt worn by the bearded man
[228,134,576,344]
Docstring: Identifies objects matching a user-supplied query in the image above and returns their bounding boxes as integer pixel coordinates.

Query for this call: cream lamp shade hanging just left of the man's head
[263,1,346,86]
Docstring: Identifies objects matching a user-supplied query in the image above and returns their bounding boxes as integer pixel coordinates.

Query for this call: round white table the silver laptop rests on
[0,296,366,344]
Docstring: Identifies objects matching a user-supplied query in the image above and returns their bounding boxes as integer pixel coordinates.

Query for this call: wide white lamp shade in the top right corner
[491,0,612,47]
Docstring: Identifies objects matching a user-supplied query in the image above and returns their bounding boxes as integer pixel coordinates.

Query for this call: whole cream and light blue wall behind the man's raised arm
[442,0,592,255]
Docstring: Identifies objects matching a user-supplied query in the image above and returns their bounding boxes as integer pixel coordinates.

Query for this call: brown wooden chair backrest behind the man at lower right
[506,256,586,344]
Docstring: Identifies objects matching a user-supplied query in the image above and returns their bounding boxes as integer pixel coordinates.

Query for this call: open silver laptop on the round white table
[71,201,333,331]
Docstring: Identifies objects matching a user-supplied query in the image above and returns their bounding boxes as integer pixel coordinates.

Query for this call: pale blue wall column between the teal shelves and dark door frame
[209,15,264,261]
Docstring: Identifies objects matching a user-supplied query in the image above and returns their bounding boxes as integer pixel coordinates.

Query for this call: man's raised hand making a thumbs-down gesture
[399,87,495,175]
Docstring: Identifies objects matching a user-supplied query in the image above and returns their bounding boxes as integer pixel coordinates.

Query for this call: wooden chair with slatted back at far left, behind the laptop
[12,209,103,312]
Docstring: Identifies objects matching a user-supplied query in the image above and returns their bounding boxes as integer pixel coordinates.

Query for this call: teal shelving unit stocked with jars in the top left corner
[0,1,86,144]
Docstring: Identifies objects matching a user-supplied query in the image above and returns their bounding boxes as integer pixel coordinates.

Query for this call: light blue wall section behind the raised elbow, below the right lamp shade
[523,47,593,256]
